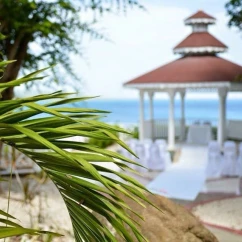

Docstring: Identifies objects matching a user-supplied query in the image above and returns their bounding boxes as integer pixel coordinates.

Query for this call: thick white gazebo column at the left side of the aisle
[168,89,176,150]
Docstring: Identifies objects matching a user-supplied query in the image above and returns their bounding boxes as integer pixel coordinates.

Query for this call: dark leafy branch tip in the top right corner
[225,0,242,31]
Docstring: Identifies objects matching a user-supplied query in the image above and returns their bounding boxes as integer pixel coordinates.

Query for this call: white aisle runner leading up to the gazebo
[147,144,207,200]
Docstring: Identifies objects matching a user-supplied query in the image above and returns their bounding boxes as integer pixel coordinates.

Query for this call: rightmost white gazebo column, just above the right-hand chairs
[218,87,228,149]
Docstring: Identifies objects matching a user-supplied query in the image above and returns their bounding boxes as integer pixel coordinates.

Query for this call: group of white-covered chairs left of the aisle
[120,139,171,172]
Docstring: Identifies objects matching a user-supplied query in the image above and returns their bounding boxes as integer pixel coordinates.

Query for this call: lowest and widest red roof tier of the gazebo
[124,56,242,85]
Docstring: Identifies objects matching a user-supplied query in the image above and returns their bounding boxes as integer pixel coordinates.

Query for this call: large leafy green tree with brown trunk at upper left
[0,0,142,95]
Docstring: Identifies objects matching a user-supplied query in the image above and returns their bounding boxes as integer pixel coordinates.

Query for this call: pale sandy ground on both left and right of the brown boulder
[0,172,242,242]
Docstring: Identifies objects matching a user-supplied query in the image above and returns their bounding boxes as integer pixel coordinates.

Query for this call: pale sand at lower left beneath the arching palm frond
[0,182,74,242]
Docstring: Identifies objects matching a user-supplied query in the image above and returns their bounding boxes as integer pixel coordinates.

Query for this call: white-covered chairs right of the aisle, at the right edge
[206,141,242,178]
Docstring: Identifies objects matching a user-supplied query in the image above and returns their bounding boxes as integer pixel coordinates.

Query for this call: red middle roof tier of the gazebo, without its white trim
[174,32,227,49]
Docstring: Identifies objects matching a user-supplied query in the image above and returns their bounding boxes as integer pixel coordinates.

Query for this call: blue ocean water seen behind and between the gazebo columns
[78,99,242,125]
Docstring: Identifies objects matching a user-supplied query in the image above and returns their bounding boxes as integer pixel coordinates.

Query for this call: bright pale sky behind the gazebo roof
[17,0,242,99]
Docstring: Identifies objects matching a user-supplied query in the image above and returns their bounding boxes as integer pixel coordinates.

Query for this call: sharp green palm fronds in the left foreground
[0,62,154,242]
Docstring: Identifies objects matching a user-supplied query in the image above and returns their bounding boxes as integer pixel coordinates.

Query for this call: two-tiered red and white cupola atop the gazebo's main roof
[173,11,227,56]
